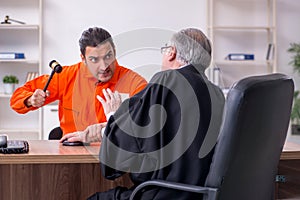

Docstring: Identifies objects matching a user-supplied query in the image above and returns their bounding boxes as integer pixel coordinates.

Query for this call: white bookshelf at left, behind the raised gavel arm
[0,0,42,139]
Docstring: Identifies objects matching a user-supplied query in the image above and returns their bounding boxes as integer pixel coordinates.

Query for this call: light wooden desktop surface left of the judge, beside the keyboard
[0,140,100,164]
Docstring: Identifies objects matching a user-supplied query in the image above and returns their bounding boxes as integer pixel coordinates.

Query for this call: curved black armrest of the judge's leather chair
[130,180,218,200]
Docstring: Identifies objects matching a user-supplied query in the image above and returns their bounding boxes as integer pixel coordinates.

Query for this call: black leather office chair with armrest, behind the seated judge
[130,74,294,200]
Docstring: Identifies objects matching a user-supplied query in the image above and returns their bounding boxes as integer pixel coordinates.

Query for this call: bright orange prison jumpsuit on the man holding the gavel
[10,62,147,135]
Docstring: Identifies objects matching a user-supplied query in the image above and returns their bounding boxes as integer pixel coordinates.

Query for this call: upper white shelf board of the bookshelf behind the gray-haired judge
[208,26,275,31]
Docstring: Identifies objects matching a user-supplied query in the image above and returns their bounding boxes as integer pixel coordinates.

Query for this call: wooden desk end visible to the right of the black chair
[276,142,300,200]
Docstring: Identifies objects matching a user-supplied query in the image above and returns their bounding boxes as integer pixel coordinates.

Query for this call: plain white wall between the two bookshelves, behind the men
[43,0,206,79]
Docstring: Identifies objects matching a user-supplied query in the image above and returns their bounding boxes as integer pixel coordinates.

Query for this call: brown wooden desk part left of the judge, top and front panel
[0,140,130,200]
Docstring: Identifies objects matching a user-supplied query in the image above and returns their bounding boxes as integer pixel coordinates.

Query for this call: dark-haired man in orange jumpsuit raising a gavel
[10,27,147,135]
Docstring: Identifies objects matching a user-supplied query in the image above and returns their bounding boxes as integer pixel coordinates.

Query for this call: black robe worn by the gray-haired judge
[90,65,224,200]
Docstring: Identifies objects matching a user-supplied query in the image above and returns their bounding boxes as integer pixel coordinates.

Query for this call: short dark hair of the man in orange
[79,27,115,57]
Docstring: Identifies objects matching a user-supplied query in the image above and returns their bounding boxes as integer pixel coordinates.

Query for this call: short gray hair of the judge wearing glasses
[170,28,211,71]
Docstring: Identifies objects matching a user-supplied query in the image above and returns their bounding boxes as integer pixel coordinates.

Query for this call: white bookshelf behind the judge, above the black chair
[207,0,277,88]
